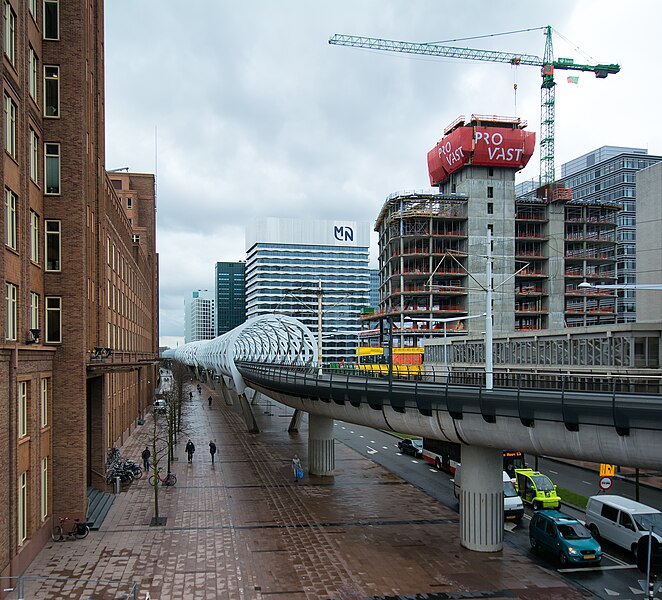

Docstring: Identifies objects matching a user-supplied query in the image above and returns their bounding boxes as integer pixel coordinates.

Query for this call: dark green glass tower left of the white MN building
[216,262,246,336]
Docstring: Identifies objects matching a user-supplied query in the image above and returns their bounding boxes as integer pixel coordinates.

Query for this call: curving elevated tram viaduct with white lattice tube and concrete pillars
[170,315,662,552]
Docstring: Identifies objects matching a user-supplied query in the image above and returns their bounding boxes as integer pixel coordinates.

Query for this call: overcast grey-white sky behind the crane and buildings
[105,0,662,346]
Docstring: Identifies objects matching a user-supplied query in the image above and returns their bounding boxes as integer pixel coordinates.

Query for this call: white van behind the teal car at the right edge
[586,495,662,555]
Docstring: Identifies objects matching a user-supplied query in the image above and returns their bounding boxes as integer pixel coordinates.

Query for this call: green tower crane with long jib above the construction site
[329,25,621,186]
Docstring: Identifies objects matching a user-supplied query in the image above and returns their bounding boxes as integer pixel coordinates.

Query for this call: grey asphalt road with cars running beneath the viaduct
[335,421,662,600]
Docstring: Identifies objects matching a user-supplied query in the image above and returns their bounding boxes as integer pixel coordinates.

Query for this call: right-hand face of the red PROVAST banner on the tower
[471,126,536,169]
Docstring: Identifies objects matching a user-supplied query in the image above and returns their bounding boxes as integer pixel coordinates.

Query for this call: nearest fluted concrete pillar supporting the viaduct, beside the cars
[460,445,503,552]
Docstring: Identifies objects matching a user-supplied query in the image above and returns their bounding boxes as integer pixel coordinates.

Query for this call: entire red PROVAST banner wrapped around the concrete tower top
[428,125,536,186]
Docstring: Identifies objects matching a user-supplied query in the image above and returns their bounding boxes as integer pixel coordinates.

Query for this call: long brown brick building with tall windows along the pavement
[0,0,158,575]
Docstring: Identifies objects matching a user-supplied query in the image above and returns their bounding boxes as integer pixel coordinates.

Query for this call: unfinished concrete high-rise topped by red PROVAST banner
[370,115,618,347]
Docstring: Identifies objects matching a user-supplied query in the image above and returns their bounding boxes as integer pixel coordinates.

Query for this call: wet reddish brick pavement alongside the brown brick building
[20,386,585,600]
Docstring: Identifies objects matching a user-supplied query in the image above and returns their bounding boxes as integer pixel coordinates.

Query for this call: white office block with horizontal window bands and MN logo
[246,218,370,362]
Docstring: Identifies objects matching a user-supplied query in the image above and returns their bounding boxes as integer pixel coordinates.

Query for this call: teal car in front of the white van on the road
[529,510,602,567]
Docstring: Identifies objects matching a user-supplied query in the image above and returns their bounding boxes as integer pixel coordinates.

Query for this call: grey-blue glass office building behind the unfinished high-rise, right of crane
[516,146,662,323]
